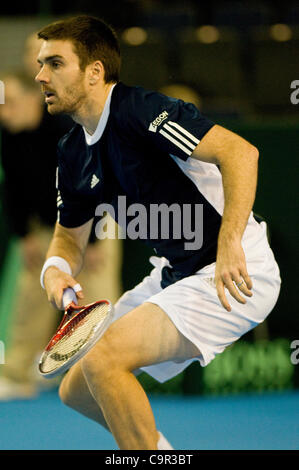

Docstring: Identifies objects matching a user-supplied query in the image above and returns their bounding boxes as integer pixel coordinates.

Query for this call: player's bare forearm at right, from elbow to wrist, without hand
[218,141,258,242]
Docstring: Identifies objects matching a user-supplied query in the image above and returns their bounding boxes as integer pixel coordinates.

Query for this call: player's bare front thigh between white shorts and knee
[83,302,200,371]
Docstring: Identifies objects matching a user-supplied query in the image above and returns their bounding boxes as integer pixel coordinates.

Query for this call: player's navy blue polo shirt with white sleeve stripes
[58,83,221,287]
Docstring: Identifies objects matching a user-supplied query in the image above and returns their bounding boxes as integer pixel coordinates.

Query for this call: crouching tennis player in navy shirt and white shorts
[36,16,280,450]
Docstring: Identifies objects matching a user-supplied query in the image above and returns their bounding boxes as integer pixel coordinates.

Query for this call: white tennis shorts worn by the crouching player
[114,224,281,382]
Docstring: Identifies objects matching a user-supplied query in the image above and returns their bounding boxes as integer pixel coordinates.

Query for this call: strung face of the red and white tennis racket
[42,304,109,372]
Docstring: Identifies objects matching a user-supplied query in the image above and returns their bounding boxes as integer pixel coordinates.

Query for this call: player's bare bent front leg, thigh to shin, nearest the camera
[82,303,200,449]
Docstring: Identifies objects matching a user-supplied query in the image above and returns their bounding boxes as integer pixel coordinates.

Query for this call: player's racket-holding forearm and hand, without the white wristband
[43,219,93,309]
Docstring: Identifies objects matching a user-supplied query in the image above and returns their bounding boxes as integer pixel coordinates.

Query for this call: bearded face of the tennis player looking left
[35,40,88,115]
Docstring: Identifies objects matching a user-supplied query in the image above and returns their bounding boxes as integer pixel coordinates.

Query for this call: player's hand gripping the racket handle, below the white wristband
[44,266,84,310]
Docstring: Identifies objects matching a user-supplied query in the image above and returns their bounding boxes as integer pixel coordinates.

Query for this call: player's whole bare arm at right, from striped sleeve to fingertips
[192,125,259,311]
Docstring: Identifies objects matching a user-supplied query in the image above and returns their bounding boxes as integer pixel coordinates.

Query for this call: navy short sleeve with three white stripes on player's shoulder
[130,88,215,160]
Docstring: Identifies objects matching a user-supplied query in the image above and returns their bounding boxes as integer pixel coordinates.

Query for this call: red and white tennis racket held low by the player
[38,288,113,378]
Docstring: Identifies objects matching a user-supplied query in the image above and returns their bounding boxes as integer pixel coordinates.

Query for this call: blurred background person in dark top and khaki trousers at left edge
[0,70,69,399]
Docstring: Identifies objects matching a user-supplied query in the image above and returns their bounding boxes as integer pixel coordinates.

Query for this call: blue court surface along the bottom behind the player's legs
[0,390,299,450]
